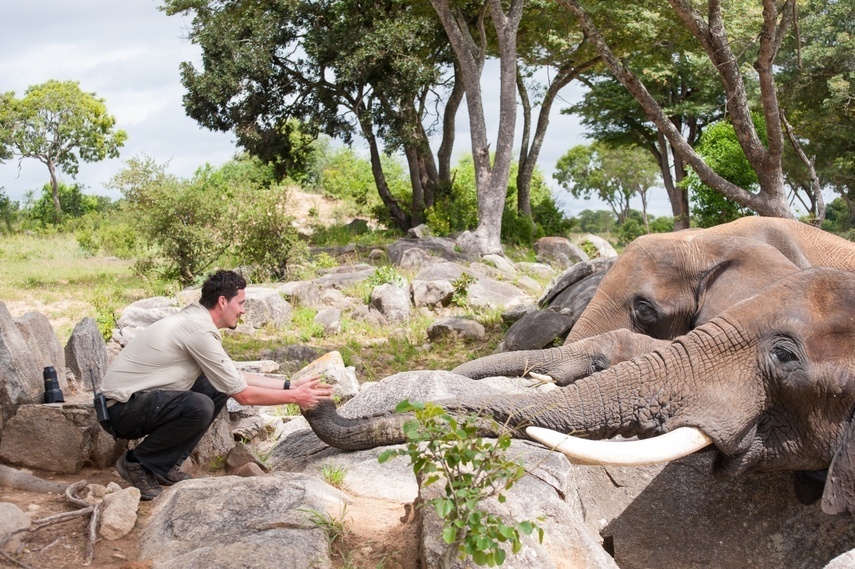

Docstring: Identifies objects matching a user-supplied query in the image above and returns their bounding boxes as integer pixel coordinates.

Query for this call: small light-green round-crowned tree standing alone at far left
[0,80,127,215]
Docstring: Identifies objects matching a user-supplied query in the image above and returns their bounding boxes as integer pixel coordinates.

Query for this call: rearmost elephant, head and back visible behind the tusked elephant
[565,217,855,344]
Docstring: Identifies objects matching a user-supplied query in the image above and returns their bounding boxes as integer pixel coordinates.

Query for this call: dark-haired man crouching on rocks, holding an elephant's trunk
[101,271,333,500]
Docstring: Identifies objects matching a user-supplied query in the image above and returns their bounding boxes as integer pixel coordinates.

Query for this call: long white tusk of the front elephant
[526,427,712,466]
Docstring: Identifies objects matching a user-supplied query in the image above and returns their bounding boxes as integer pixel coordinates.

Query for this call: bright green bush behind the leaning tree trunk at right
[681,117,765,227]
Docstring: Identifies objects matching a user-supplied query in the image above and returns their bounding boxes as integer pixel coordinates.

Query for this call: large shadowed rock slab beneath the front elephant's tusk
[575,452,855,569]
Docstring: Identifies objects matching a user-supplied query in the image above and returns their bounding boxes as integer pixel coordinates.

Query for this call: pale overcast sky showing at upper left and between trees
[0,0,670,215]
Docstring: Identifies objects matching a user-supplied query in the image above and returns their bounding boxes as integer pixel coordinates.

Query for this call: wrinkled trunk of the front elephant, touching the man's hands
[303,319,763,455]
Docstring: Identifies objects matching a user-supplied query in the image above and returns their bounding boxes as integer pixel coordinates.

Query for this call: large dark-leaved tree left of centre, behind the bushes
[166,0,462,230]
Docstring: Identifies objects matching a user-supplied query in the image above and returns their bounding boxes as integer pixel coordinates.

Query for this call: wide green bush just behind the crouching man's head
[110,157,307,286]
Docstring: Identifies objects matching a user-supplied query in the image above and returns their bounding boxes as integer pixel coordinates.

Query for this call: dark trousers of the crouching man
[108,375,229,476]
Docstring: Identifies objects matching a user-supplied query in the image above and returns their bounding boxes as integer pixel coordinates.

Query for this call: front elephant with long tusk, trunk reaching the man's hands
[303,268,855,514]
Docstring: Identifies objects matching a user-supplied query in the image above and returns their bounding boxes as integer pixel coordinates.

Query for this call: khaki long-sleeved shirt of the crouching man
[101,303,247,402]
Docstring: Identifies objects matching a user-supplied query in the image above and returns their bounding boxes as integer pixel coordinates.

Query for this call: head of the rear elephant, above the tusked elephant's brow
[565,230,800,344]
